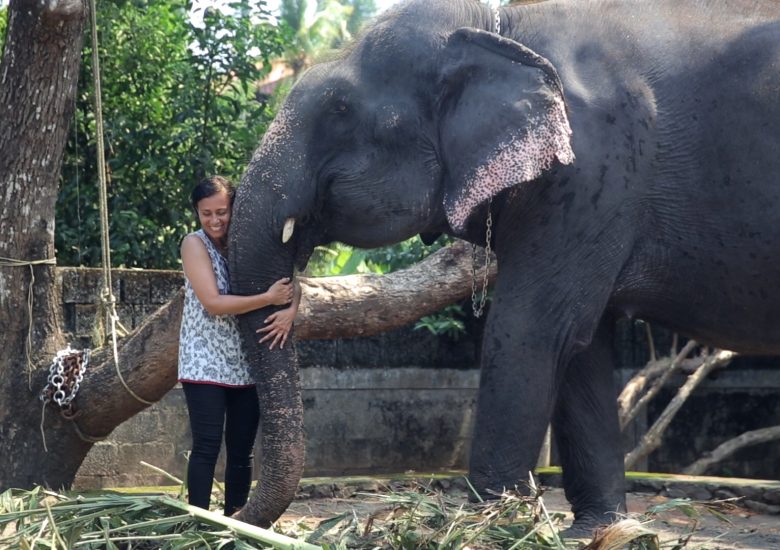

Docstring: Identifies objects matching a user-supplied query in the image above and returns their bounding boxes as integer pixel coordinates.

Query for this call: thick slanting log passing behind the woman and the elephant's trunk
[70,241,497,439]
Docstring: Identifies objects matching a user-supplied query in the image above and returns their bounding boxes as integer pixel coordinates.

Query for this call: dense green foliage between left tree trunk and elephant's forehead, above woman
[56,0,286,268]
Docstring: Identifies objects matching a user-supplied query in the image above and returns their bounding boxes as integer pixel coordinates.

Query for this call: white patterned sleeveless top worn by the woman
[179,229,254,386]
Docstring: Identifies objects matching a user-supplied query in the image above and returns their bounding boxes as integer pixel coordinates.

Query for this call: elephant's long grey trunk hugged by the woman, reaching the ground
[229,110,304,526]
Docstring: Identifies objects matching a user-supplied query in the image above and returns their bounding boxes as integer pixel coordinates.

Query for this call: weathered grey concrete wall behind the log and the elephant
[61,268,780,488]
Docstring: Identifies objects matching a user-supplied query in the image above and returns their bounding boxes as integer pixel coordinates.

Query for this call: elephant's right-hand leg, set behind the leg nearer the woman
[553,319,626,535]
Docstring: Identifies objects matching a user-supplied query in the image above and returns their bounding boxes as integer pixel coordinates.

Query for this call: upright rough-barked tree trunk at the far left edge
[0,0,89,487]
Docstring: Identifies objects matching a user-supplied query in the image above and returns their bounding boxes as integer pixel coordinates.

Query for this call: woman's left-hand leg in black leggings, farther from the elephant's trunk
[182,382,225,509]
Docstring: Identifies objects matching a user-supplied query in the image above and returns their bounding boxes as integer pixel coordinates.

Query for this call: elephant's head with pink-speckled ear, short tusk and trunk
[225,0,573,522]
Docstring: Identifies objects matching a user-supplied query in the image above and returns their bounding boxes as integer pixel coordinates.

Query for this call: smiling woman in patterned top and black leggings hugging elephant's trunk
[179,176,299,515]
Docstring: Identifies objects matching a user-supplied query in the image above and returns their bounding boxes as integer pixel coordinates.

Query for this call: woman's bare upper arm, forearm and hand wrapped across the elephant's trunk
[181,235,293,315]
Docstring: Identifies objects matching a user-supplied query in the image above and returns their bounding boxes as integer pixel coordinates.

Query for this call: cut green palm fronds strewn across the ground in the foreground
[0,483,731,550]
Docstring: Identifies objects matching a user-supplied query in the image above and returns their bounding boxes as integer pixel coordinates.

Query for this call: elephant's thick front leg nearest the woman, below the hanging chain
[469,288,561,498]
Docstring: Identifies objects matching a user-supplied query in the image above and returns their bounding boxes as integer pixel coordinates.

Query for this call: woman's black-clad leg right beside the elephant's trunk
[225,387,260,516]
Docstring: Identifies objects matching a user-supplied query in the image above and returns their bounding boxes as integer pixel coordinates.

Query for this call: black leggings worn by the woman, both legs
[182,382,260,516]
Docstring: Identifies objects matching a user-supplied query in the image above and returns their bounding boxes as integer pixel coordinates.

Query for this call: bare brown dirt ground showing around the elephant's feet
[280,489,780,550]
